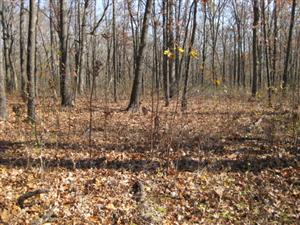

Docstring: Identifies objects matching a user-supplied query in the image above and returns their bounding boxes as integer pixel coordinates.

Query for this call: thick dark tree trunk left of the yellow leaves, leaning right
[127,0,152,111]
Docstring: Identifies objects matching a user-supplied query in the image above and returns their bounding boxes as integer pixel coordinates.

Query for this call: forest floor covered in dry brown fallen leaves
[0,92,300,225]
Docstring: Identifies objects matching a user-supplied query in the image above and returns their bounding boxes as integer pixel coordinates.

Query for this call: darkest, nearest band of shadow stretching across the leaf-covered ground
[0,156,300,173]
